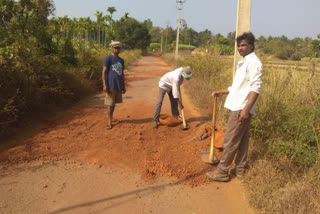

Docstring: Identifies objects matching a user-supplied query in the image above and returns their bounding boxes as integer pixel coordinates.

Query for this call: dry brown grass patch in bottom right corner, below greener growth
[245,159,320,214]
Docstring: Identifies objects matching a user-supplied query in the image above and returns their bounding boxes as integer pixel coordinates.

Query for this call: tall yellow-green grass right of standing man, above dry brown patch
[252,67,320,166]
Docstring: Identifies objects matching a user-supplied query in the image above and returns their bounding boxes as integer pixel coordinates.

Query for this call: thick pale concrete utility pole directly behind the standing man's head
[233,0,251,76]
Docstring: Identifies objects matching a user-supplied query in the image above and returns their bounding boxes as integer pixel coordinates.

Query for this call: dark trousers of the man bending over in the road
[153,88,179,121]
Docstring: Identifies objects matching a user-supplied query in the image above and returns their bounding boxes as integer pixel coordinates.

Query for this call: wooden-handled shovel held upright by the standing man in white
[200,96,219,164]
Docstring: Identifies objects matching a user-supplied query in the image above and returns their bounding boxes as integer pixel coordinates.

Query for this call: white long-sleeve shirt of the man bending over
[159,67,183,98]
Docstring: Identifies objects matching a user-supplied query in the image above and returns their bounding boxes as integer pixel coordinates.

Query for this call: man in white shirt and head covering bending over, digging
[152,66,192,128]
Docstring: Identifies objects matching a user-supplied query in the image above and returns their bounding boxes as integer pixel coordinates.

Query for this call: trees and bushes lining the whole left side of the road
[0,0,146,136]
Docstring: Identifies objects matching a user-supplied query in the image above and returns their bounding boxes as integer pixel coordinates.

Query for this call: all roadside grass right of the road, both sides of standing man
[165,54,320,213]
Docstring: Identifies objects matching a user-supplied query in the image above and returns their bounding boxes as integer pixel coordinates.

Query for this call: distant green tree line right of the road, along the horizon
[149,23,320,61]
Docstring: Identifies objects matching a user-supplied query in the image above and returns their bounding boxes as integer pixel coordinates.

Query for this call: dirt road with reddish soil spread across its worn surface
[0,57,253,213]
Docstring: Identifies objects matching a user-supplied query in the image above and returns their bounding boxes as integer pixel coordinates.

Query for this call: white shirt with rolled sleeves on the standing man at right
[224,52,263,114]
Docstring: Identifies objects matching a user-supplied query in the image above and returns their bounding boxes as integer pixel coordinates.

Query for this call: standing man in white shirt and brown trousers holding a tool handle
[206,32,263,181]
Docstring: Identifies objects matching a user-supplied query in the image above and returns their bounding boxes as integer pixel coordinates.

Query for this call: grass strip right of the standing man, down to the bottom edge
[245,68,320,214]
